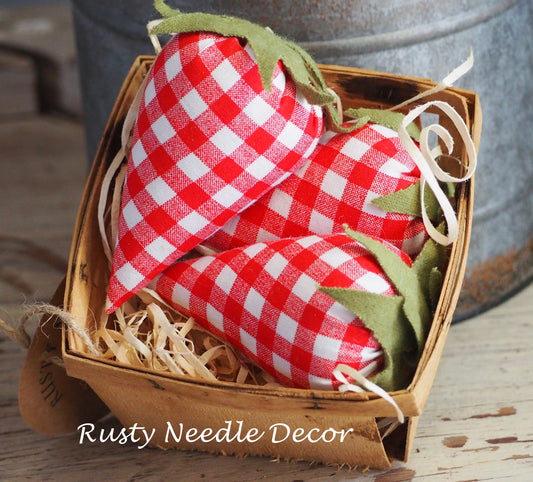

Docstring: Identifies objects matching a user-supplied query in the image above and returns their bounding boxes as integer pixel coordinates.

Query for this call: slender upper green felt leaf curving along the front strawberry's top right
[345,226,431,355]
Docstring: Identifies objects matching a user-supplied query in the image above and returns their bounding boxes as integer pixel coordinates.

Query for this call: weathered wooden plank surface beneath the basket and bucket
[0,116,533,481]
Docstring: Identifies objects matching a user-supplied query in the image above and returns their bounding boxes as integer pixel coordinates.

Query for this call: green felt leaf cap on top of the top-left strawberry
[152,0,353,132]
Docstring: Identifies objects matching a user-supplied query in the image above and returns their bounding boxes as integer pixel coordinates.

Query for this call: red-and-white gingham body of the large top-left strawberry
[107,33,323,312]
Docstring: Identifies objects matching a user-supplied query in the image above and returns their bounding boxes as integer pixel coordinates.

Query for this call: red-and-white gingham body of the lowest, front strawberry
[150,233,410,390]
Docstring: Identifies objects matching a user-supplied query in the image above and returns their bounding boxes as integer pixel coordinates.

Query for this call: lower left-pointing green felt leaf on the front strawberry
[319,286,417,391]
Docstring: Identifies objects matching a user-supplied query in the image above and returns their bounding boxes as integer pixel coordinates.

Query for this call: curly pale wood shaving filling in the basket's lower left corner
[93,289,275,385]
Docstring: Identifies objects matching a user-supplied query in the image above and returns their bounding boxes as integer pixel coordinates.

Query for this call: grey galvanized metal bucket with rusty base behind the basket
[73,0,533,319]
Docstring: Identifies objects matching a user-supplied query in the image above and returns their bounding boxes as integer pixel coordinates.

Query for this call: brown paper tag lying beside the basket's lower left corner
[19,281,109,434]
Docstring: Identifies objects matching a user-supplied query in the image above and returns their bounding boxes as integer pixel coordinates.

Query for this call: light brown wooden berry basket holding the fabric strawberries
[62,57,481,468]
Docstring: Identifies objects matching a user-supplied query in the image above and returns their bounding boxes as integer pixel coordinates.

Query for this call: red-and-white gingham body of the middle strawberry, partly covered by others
[204,124,427,256]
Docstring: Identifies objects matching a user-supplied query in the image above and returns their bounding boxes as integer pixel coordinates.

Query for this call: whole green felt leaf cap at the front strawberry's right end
[319,225,445,391]
